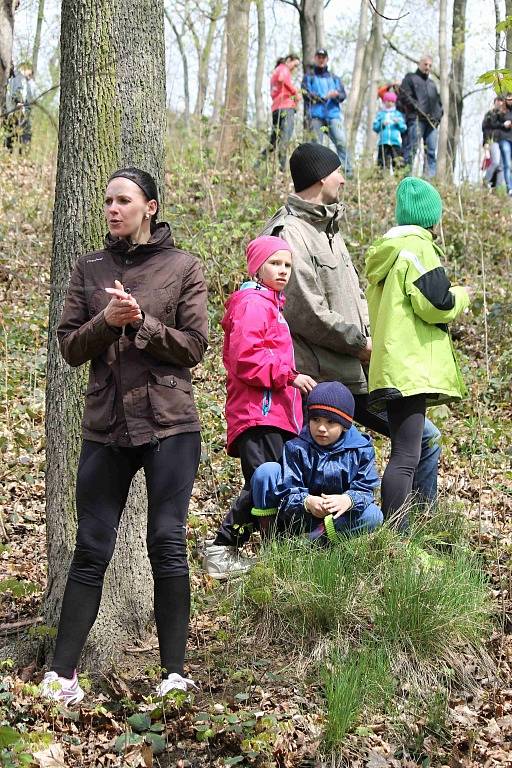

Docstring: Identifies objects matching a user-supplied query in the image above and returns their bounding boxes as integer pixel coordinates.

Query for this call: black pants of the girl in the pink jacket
[214,427,295,547]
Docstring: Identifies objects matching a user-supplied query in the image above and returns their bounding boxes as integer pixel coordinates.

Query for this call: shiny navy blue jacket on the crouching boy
[277,425,379,520]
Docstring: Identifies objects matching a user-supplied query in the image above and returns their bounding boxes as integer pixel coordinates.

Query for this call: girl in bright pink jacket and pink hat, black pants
[204,236,316,579]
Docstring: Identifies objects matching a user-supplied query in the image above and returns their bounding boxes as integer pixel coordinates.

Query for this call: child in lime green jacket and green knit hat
[366,176,470,529]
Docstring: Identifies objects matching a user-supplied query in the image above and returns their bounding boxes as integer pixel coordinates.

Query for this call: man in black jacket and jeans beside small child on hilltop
[400,54,443,176]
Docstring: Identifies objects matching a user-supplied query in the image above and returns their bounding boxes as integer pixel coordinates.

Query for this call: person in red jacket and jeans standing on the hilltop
[257,53,300,171]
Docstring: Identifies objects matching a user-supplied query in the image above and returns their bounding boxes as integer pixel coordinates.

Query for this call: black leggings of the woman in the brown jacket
[51,432,201,678]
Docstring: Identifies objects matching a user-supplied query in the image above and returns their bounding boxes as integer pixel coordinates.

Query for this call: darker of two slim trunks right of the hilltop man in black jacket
[448,0,467,171]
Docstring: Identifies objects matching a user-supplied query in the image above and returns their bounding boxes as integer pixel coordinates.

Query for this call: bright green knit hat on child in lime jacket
[395,176,443,229]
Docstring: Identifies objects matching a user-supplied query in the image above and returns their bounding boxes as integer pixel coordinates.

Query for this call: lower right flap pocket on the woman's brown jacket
[148,371,197,426]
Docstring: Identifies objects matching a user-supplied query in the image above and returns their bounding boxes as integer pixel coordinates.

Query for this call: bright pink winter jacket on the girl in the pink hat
[222,281,302,456]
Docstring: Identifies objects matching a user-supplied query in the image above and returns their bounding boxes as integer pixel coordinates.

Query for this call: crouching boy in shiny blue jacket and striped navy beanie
[252,381,383,543]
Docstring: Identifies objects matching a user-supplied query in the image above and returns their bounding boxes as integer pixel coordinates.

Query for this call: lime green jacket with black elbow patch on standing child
[366,226,469,412]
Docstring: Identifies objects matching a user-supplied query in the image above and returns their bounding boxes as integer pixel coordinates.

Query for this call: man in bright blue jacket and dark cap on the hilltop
[302,48,352,177]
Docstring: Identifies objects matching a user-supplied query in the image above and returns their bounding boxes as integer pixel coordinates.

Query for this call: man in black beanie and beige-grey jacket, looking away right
[263,143,440,510]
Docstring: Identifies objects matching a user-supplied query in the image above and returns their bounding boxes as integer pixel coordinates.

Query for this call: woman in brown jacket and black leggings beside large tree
[41,168,208,705]
